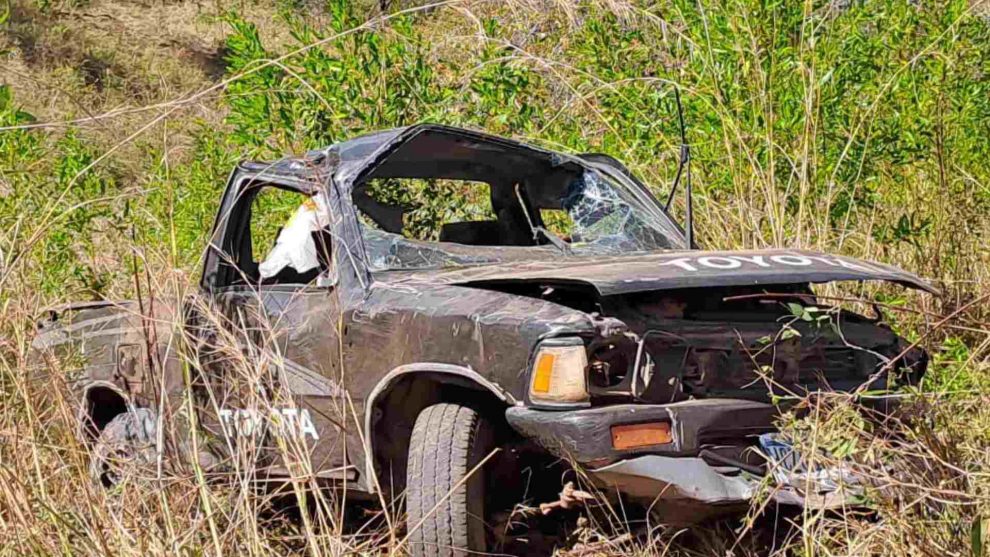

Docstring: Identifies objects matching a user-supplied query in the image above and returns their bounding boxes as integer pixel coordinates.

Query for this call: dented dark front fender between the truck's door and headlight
[345,285,595,398]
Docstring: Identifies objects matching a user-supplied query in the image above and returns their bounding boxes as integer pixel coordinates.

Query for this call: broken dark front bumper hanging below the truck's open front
[506,399,859,524]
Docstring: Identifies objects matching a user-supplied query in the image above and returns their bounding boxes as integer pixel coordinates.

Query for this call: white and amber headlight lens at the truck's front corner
[529,338,588,404]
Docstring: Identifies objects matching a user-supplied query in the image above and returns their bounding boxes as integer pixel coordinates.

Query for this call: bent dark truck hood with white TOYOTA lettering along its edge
[389,250,938,296]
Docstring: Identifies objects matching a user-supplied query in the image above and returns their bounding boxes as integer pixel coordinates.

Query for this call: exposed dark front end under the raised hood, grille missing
[588,287,927,403]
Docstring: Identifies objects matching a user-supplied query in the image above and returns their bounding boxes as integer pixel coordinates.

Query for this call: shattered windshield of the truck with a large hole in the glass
[355,169,684,271]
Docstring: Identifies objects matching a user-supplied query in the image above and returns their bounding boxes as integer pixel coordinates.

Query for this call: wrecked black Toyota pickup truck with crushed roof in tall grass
[35,125,933,555]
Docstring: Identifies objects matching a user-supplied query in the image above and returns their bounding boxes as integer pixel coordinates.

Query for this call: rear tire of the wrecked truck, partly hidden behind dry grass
[89,408,158,488]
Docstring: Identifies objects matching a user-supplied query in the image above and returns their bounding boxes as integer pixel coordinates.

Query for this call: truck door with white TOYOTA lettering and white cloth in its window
[200,175,356,479]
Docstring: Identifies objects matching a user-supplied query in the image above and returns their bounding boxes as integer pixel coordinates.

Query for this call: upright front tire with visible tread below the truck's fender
[406,404,494,557]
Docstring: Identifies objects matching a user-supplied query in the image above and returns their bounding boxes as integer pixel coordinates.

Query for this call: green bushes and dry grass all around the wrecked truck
[0,0,990,555]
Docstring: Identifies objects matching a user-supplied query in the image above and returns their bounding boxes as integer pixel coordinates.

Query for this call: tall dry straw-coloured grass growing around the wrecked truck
[0,2,990,555]
